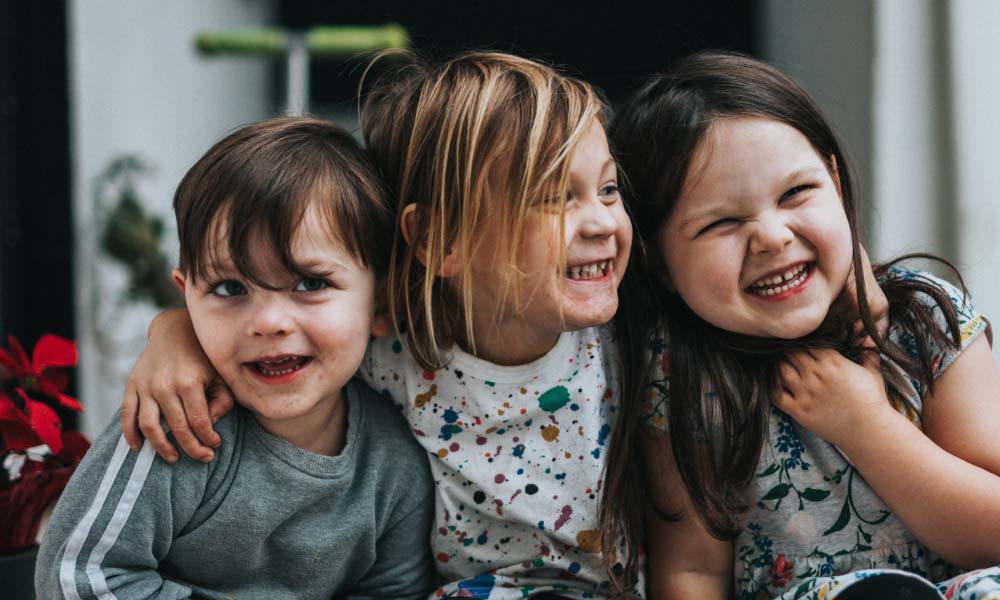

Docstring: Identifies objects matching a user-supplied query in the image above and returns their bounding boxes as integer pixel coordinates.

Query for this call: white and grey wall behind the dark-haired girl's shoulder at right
[759,0,1000,357]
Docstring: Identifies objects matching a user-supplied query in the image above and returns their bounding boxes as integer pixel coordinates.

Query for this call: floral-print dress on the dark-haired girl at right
[647,268,1000,600]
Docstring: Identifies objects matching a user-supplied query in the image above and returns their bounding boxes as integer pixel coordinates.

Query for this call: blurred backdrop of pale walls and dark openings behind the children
[0,0,1000,436]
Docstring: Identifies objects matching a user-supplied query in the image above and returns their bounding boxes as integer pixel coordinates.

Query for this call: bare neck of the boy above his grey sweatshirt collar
[254,389,348,456]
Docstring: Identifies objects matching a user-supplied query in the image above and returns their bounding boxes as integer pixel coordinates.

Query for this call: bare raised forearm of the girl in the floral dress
[841,411,1000,568]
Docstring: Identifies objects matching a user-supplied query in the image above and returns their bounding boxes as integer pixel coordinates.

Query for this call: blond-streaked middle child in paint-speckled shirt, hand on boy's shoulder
[111,53,632,599]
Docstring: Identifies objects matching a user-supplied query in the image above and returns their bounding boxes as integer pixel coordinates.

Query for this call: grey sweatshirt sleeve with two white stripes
[35,417,208,600]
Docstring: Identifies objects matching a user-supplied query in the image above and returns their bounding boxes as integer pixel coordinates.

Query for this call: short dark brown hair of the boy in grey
[174,117,393,288]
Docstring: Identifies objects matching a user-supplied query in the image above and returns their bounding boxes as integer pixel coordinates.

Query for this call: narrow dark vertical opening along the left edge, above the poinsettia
[0,0,75,400]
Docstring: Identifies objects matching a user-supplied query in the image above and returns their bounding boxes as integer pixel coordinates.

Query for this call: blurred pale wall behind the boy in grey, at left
[68,0,276,437]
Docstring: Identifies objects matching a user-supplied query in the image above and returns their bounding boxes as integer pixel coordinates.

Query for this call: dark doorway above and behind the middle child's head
[279,0,757,104]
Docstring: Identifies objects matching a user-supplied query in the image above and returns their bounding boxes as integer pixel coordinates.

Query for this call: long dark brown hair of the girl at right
[602,52,960,592]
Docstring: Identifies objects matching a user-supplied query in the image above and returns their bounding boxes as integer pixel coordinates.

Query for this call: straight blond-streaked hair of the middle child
[360,52,607,369]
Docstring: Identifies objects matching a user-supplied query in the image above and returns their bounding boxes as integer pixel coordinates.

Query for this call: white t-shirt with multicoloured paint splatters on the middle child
[362,327,632,600]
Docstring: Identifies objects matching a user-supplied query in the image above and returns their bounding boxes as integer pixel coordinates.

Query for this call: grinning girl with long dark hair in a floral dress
[608,53,1000,599]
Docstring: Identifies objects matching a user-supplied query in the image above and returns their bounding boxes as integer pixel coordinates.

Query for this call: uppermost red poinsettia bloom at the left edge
[0,333,83,410]
